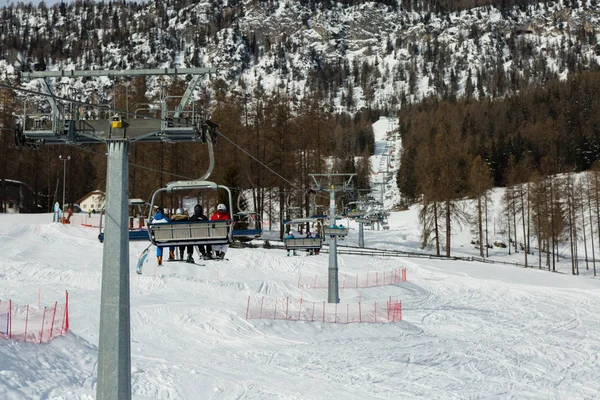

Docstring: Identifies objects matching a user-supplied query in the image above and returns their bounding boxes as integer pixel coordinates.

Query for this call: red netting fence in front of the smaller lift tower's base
[246,296,402,324]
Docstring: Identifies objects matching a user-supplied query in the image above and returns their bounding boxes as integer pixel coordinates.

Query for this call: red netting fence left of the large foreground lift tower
[0,292,69,343]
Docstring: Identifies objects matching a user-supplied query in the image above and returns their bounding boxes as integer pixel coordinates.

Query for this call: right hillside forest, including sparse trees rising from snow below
[398,71,600,274]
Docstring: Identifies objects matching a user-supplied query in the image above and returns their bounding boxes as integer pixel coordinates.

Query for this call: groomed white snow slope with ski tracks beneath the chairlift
[0,209,600,400]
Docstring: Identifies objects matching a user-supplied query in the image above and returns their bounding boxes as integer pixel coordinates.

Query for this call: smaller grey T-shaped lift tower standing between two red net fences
[309,174,356,303]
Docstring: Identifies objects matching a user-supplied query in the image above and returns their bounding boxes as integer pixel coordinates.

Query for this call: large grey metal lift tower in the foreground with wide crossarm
[15,68,217,400]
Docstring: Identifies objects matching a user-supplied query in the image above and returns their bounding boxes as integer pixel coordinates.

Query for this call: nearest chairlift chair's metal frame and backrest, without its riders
[148,180,233,247]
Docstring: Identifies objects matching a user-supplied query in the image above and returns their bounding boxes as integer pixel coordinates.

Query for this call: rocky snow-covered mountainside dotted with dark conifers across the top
[0,0,600,112]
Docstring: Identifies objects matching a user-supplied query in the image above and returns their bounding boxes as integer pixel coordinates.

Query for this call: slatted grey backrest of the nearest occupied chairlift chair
[148,221,231,247]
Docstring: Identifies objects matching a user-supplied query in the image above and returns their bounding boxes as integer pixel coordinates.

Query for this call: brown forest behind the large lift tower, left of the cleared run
[0,78,378,220]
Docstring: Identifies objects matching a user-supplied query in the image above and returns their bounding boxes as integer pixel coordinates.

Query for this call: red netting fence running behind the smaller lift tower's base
[298,267,406,289]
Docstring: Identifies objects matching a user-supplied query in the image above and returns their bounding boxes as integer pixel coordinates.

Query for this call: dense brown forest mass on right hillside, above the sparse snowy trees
[398,71,600,201]
